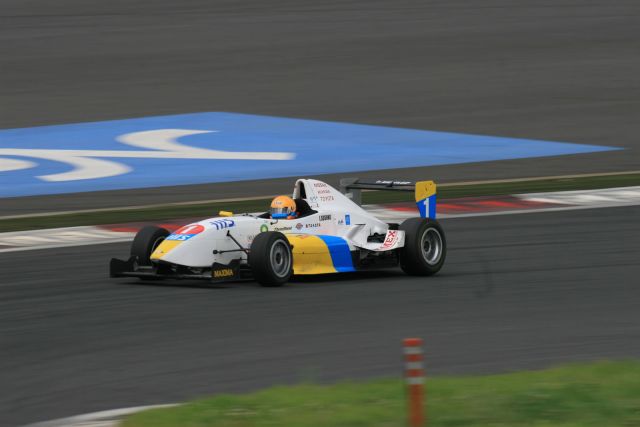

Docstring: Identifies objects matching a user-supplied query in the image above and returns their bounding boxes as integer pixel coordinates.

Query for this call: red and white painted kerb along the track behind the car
[0,186,640,253]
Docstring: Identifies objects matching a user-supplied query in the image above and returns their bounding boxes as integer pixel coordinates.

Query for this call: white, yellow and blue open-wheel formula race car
[110,179,447,286]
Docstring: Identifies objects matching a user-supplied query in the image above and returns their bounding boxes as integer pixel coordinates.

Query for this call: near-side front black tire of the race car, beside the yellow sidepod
[248,231,293,287]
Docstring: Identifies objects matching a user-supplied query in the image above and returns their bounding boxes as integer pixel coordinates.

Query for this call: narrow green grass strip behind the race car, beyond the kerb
[0,173,640,232]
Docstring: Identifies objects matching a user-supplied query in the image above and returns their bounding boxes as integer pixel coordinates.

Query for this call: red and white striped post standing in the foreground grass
[403,338,425,427]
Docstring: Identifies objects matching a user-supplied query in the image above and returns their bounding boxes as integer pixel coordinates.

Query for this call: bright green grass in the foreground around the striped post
[122,361,640,427]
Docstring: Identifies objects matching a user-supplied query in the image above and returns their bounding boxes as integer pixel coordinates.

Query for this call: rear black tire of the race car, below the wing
[400,218,447,276]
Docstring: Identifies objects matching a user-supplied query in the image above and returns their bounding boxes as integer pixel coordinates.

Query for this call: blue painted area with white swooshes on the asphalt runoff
[0,112,617,197]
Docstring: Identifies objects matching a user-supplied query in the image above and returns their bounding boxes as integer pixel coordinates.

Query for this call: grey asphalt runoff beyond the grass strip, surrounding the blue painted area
[0,0,640,215]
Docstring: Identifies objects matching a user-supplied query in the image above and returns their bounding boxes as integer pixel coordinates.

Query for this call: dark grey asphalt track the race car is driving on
[0,207,640,426]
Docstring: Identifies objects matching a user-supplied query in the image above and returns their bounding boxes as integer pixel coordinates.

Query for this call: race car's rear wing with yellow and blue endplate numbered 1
[340,178,436,218]
